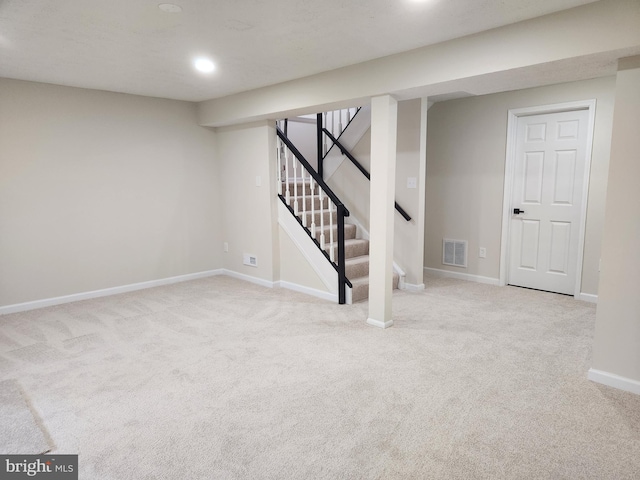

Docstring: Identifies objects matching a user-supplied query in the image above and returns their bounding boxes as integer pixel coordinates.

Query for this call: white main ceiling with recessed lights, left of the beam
[0,0,594,101]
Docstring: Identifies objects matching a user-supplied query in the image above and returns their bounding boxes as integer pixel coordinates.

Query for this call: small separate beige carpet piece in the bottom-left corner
[0,380,51,455]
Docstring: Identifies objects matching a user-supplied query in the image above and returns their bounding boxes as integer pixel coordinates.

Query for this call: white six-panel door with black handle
[508,110,589,295]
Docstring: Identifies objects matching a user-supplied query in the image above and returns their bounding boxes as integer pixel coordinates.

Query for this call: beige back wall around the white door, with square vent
[424,77,615,294]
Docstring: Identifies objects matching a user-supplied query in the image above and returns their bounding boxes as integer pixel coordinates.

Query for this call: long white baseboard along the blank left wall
[0,269,224,315]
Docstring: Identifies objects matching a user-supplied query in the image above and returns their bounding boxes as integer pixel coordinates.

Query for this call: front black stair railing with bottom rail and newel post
[276,126,353,305]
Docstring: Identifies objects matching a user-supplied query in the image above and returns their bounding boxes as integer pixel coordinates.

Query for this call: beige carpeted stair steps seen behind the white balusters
[282,182,400,303]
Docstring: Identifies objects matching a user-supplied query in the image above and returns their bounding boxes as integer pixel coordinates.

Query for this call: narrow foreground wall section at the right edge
[593,57,640,388]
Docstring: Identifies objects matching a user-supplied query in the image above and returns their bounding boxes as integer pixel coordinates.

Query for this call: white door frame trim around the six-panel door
[500,99,596,298]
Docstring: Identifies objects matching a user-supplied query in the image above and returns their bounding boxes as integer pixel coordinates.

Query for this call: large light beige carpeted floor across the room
[0,277,640,480]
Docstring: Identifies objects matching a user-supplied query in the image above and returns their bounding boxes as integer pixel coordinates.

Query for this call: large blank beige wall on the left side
[0,79,221,306]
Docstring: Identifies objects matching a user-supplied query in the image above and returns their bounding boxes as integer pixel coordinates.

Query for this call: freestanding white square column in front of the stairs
[367,95,398,328]
